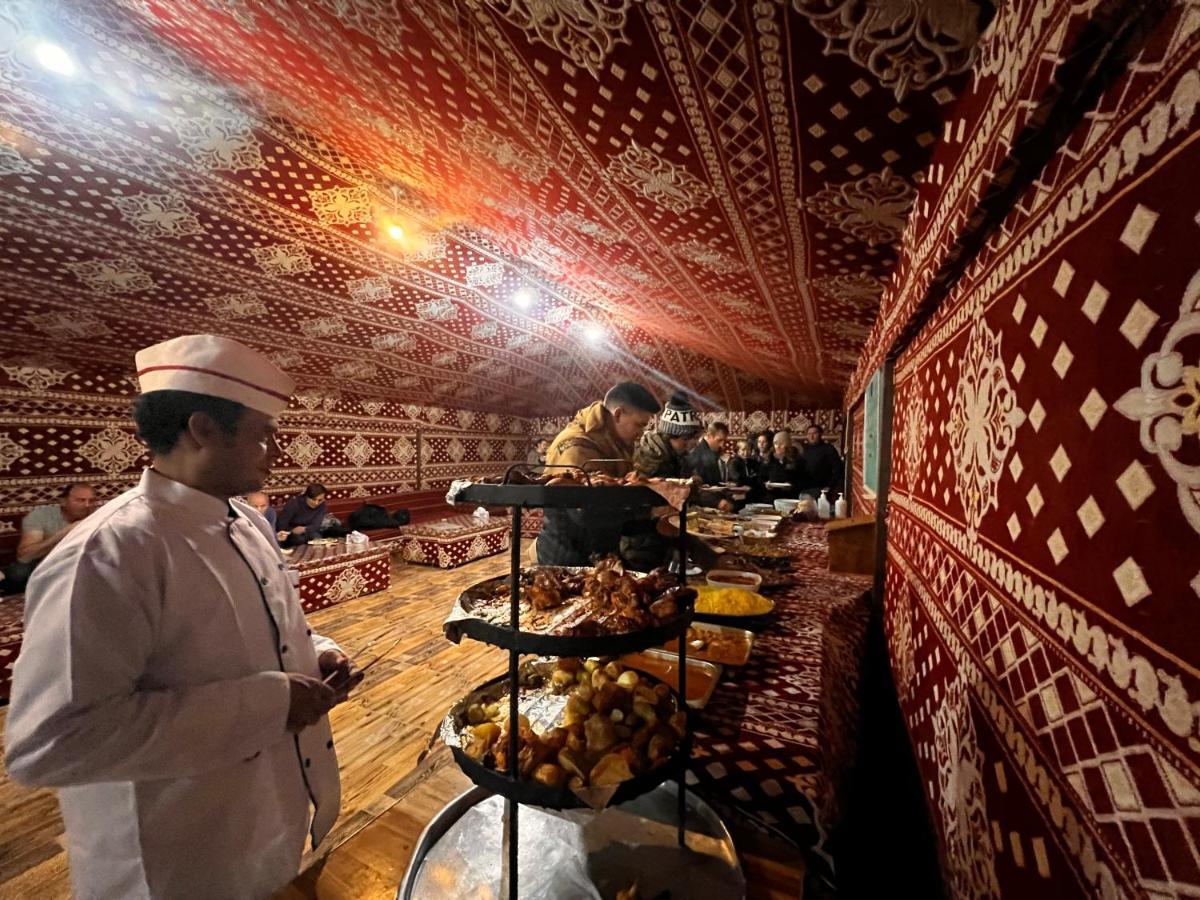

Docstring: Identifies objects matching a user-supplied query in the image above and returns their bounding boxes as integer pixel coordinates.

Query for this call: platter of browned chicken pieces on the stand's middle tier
[442,560,696,656]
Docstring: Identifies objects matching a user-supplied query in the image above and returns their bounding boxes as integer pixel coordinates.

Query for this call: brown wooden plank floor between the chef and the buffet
[0,554,803,900]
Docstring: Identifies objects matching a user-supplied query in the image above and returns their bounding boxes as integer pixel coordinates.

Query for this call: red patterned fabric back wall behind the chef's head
[0,358,532,536]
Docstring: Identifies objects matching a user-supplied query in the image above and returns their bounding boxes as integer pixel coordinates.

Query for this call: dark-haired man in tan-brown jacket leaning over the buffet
[538,382,659,565]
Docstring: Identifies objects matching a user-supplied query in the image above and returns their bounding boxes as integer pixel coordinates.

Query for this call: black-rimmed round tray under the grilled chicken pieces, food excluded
[442,570,692,656]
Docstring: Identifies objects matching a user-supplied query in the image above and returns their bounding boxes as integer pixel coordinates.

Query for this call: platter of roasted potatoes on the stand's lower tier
[439,659,688,809]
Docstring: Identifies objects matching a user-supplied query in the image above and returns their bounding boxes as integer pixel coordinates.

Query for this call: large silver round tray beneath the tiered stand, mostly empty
[396,784,745,900]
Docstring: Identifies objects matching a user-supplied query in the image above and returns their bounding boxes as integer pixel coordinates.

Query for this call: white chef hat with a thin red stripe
[133,335,296,416]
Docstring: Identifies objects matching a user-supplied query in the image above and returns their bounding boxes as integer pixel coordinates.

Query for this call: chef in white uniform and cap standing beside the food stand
[5,335,359,900]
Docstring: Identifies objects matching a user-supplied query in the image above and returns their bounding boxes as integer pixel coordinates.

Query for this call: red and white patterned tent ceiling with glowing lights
[0,0,990,415]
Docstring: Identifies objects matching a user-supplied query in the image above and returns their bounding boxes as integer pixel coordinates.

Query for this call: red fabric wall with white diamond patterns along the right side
[864,4,1200,898]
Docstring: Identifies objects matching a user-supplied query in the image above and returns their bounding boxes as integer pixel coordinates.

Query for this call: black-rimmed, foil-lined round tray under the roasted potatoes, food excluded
[439,660,691,810]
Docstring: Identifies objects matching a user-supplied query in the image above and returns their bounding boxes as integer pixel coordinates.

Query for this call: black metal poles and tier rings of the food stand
[434,485,691,900]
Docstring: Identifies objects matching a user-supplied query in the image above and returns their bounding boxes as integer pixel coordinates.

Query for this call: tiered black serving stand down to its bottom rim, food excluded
[397,475,740,900]
